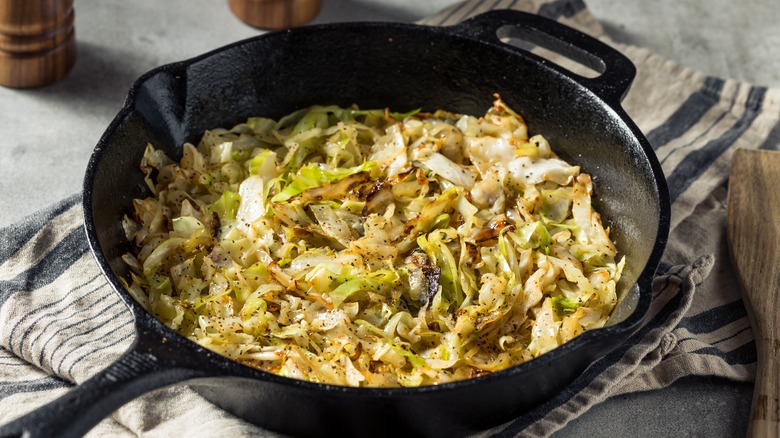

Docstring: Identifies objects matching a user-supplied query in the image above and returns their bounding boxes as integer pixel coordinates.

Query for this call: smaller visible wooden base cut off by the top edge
[228,0,322,30]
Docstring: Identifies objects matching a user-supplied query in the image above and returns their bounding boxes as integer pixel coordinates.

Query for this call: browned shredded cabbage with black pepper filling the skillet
[122,96,625,387]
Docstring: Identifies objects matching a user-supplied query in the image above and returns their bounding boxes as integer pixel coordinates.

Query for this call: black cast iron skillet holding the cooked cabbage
[0,11,669,436]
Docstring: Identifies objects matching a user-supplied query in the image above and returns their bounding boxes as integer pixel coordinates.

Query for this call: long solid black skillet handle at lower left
[0,336,205,438]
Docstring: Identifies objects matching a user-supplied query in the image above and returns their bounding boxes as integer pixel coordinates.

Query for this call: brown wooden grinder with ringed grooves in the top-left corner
[0,0,76,88]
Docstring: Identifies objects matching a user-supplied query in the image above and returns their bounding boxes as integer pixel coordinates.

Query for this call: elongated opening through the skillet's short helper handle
[496,25,607,79]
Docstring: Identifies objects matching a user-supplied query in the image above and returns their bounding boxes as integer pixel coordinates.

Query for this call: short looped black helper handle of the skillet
[451,10,636,104]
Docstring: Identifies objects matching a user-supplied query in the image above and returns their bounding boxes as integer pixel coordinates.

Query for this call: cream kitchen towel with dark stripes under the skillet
[0,0,780,437]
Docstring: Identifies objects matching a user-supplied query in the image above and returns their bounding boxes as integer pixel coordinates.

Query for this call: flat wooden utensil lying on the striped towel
[727,149,780,437]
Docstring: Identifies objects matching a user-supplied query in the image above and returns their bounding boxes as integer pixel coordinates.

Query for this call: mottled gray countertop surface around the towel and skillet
[0,0,780,437]
